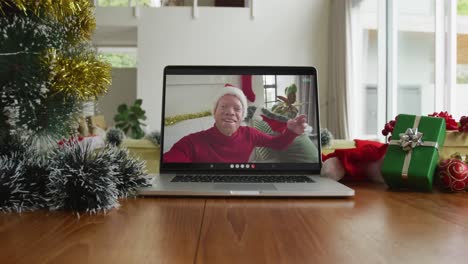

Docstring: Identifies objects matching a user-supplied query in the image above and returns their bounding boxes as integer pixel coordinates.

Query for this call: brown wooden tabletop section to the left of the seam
[0,198,205,263]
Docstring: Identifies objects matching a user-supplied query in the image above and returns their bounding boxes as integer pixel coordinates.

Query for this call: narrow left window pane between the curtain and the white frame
[348,0,385,139]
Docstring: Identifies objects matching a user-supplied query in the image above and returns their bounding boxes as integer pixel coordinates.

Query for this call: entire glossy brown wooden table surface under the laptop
[0,183,468,264]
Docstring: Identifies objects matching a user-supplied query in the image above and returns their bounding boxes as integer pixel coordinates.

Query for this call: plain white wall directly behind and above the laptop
[137,0,329,130]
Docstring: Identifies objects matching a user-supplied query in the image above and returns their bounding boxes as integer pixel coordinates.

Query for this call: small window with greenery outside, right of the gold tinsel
[97,47,137,68]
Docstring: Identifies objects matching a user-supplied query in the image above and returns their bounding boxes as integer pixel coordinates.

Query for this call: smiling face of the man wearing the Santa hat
[214,94,243,136]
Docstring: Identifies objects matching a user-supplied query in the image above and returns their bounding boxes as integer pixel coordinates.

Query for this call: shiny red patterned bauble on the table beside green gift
[439,159,468,192]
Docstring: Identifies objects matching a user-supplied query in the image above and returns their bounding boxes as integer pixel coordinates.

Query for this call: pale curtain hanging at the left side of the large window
[327,0,356,139]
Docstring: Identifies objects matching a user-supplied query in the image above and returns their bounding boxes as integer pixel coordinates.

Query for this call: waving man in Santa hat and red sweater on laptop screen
[163,84,306,163]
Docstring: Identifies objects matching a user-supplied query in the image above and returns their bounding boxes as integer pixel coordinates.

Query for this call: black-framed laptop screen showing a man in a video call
[160,66,321,172]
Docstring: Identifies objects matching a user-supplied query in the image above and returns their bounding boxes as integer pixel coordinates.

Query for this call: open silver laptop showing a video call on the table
[138,66,354,197]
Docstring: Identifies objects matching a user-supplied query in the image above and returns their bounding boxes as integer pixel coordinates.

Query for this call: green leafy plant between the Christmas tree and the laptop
[114,99,146,139]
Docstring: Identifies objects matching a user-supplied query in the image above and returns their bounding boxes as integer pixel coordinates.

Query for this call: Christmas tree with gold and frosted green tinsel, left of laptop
[0,0,145,213]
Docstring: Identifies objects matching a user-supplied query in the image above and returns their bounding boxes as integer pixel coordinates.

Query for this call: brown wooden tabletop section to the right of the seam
[197,184,468,263]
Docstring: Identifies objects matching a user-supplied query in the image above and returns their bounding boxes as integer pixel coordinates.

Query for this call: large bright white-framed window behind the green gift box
[348,0,468,140]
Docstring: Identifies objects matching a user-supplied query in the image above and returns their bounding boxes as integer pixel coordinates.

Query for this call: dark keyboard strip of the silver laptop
[171,175,314,183]
